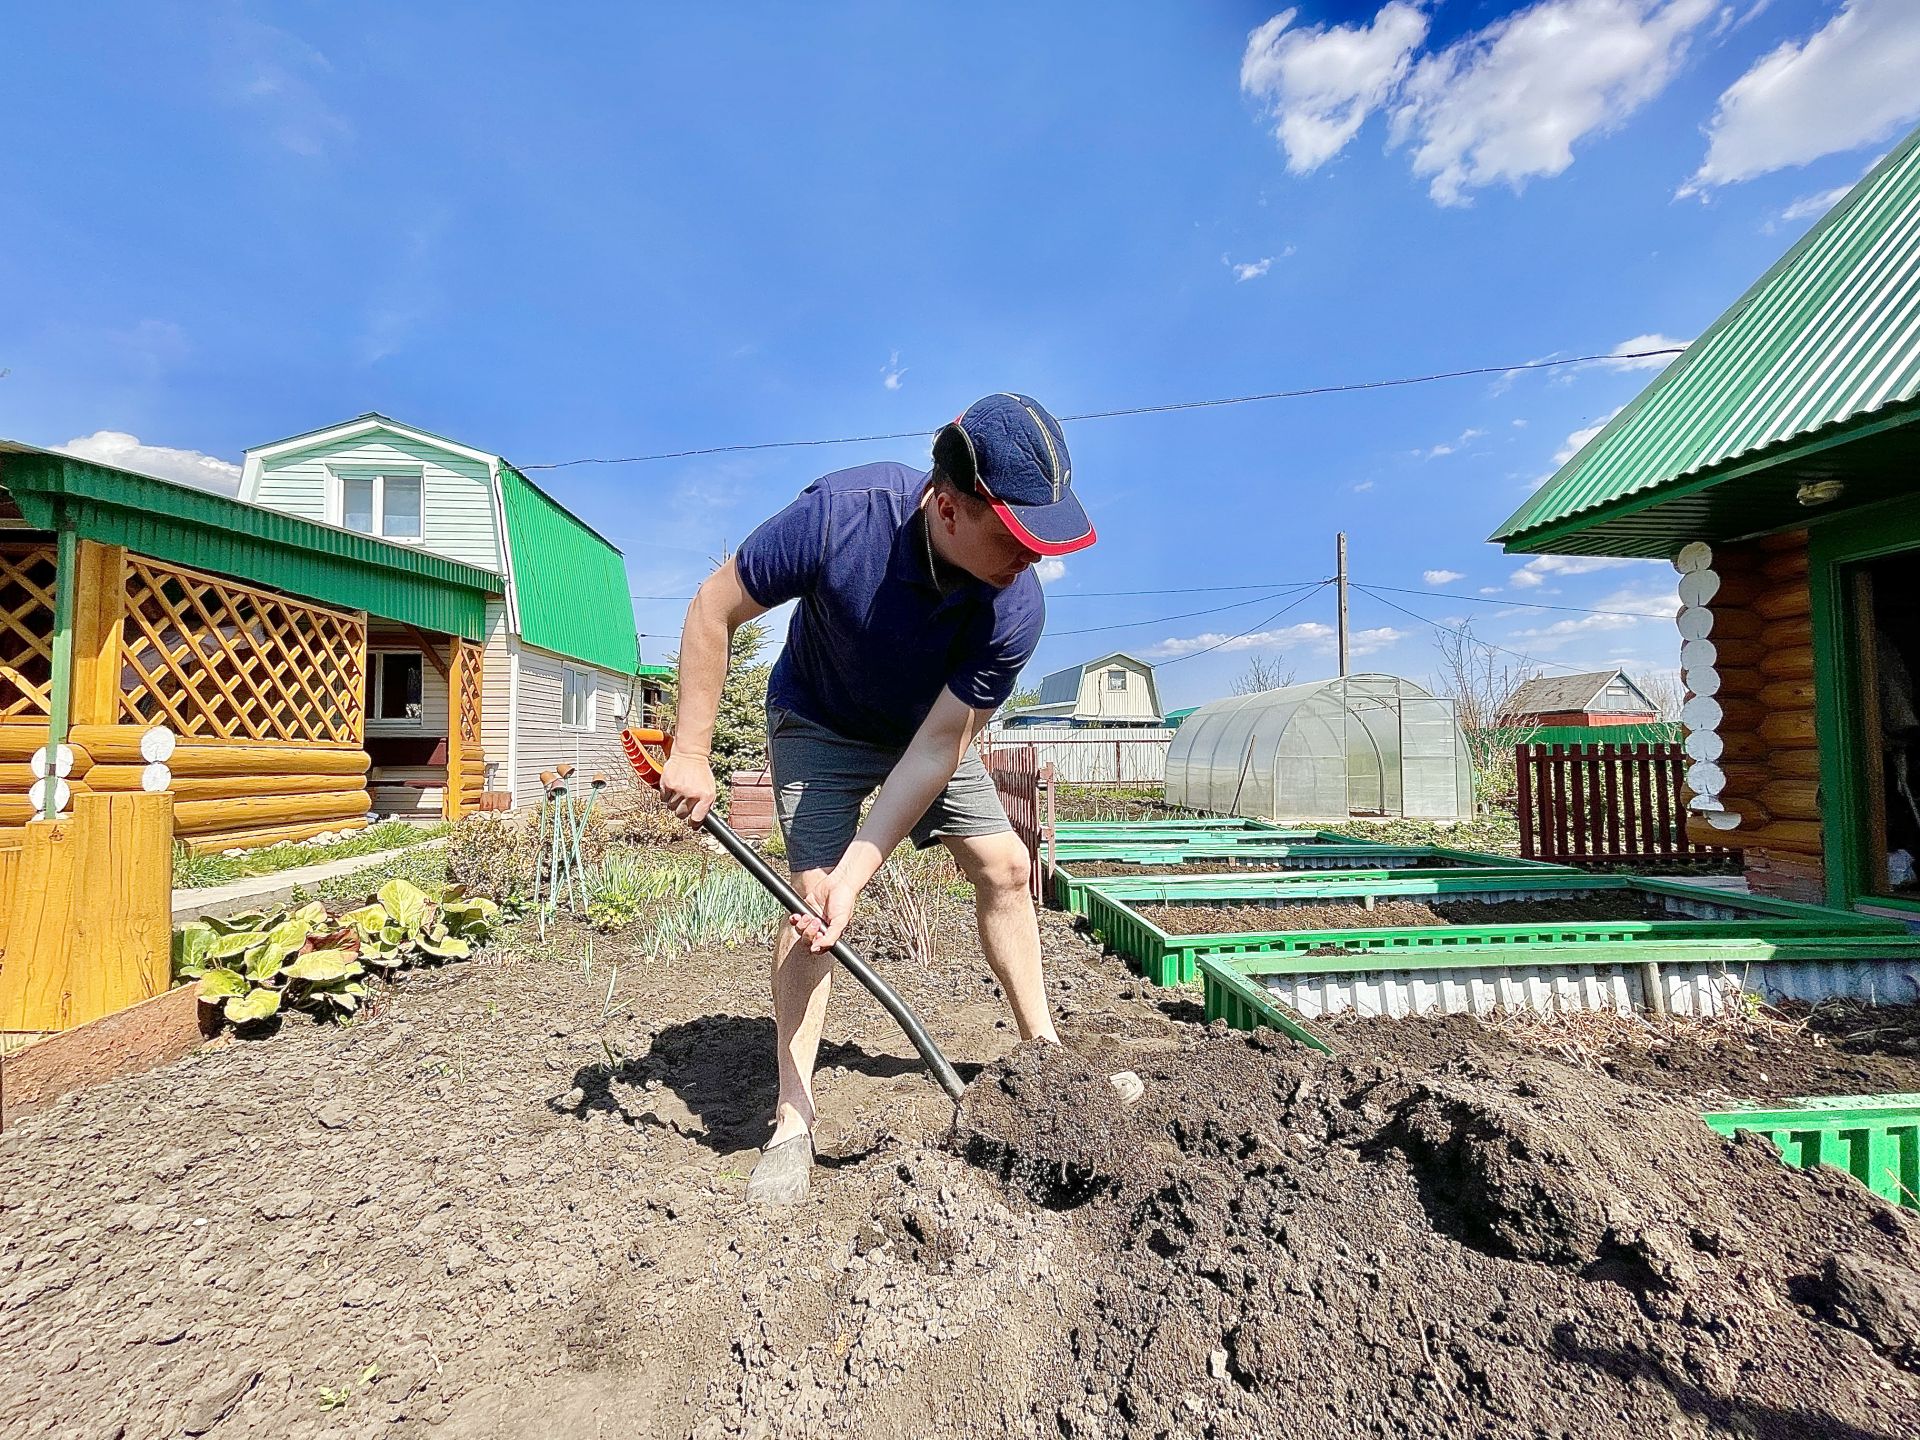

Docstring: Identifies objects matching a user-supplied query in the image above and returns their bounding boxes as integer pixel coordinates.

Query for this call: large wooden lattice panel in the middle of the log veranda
[121,555,367,745]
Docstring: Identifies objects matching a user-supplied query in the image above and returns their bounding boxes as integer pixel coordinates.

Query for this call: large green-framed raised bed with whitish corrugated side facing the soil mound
[1087,874,1920,990]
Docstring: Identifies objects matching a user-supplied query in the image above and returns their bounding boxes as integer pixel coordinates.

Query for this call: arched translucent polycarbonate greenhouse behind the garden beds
[1167,674,1473,820]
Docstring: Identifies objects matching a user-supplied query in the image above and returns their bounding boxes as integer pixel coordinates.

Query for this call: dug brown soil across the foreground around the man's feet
[0,875,1920,1440]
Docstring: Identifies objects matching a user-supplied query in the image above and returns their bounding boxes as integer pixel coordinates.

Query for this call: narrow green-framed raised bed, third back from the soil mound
[1054,841,1571,916]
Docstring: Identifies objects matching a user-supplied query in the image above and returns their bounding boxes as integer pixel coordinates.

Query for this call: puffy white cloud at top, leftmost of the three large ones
[1240,0,1428,175]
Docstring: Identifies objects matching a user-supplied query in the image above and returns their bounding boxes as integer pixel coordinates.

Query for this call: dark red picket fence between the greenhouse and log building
[1513,743,1738,866]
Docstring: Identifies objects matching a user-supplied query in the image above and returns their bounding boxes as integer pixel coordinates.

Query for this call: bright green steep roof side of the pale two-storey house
[499,461,639,674]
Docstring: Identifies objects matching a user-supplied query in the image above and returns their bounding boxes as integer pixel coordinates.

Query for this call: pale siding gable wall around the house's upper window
[242,432,505,572]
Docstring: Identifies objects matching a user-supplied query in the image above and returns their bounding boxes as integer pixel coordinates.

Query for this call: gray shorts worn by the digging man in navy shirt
[766,705,1012,872]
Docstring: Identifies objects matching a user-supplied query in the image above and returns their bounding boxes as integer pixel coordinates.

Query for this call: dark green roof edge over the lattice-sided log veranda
[0,440,503,639]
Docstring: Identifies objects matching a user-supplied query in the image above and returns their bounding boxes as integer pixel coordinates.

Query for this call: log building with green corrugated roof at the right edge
[1494,118,1920,922]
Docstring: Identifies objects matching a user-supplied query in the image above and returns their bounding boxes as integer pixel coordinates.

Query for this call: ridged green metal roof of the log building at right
[1494,131,1920,553]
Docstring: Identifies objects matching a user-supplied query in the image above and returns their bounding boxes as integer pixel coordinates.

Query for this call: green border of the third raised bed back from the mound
[1052,845,1580,916]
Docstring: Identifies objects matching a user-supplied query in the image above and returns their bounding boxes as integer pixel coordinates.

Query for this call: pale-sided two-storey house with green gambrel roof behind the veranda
[240,415,666,814]
